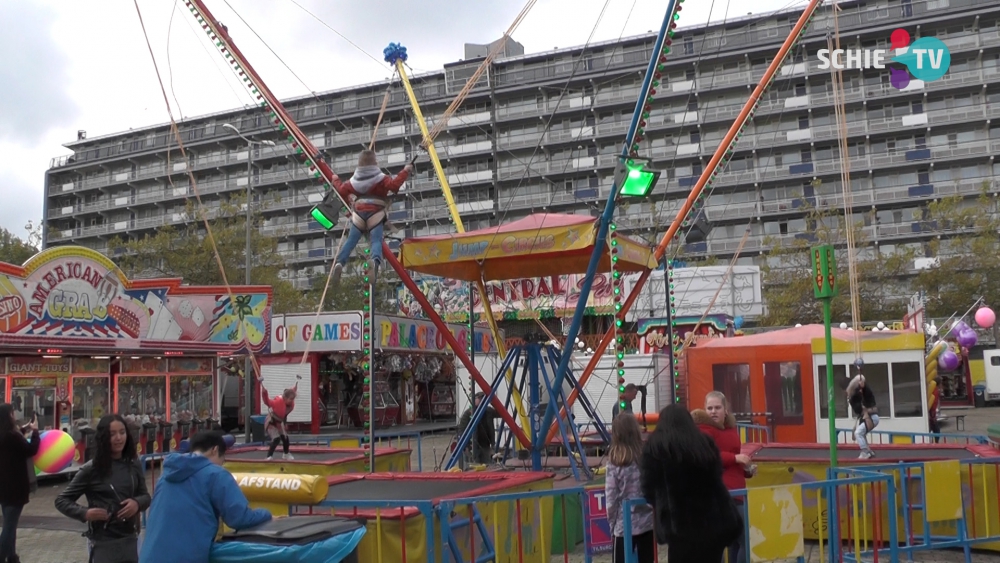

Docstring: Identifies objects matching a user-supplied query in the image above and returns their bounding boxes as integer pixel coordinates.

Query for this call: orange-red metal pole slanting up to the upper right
[546,0,822,443]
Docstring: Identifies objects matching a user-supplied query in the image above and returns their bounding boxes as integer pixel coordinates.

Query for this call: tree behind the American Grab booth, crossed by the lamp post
[108,196,308,314]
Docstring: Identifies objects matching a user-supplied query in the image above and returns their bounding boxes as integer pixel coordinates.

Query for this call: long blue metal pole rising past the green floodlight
[535,0,678,449]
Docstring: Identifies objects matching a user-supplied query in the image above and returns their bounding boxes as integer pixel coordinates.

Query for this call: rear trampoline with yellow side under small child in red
[225,446,410,476]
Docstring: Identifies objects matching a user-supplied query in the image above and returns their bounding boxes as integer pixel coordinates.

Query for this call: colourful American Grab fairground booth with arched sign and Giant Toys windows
[0,246,271,472]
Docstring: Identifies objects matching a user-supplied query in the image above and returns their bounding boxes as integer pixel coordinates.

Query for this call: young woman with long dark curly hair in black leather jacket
[56,414,150,563]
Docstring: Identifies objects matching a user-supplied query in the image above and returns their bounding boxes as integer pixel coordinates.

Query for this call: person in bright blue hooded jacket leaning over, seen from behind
[139,431,271,563]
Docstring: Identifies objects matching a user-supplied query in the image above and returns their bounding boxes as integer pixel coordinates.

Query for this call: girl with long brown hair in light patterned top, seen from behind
[604,413,656,563]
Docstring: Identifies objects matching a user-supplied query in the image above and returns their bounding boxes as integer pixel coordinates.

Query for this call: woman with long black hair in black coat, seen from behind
[639,405,743,563]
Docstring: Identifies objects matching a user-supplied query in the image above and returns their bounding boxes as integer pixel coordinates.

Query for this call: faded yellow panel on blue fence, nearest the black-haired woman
[747,485,805,563]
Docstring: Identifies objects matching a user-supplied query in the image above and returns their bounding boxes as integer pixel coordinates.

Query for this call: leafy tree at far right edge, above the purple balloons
[914,189,1000,317]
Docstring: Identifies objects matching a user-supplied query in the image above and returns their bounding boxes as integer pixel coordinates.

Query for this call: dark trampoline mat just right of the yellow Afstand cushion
[326,479,498,500]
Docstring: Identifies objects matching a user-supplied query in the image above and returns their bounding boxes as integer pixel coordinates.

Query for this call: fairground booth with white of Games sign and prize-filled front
[268,311,497,433]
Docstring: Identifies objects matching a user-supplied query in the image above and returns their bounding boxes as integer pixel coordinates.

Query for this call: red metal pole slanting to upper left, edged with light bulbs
[185,0,531,448]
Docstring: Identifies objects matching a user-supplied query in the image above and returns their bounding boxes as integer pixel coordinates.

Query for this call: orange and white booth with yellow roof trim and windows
[686,325,928,443]
